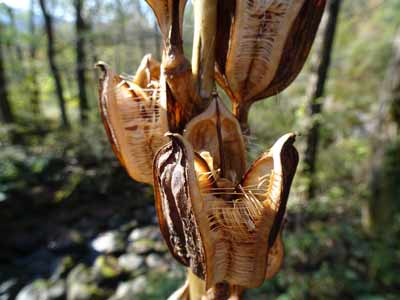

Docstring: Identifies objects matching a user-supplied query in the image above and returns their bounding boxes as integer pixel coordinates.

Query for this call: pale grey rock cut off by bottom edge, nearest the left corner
[16,279,66,300]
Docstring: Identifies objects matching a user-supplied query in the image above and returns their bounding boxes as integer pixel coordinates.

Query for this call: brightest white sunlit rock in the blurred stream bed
[91,231,125,254]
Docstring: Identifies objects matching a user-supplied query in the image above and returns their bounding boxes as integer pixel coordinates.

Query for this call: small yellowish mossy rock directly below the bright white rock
[92,255,122,284]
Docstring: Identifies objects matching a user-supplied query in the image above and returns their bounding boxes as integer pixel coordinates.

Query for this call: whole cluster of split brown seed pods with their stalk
[98,0,325,300]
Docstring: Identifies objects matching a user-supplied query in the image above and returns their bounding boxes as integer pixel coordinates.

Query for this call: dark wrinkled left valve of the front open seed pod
[153,135,207,278]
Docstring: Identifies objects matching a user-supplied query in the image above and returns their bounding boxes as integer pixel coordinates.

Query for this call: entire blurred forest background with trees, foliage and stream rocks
[0,0,400,300]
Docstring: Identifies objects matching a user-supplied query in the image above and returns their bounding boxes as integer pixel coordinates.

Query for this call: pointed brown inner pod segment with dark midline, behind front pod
[184,94,246,184]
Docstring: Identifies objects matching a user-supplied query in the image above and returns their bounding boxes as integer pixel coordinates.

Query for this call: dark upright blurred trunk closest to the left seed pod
[74,0,89,123]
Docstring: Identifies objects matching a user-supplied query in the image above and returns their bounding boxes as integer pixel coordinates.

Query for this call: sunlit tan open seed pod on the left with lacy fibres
[98,55,168,184]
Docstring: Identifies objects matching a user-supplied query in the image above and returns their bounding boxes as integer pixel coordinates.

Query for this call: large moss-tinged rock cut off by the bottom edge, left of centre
[67,264,112,300]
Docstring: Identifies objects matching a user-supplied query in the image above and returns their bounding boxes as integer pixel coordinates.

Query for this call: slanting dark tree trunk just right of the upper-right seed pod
[304,0,341,199]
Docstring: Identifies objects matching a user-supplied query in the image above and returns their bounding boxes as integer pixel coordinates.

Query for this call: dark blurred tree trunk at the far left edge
[0,23,14,124]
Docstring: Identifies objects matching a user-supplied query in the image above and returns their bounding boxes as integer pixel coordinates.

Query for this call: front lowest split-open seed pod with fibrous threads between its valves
[154,134,298,289]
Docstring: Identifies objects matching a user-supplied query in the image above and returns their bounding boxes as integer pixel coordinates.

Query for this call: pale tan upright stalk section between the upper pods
[192,0,218,100]
